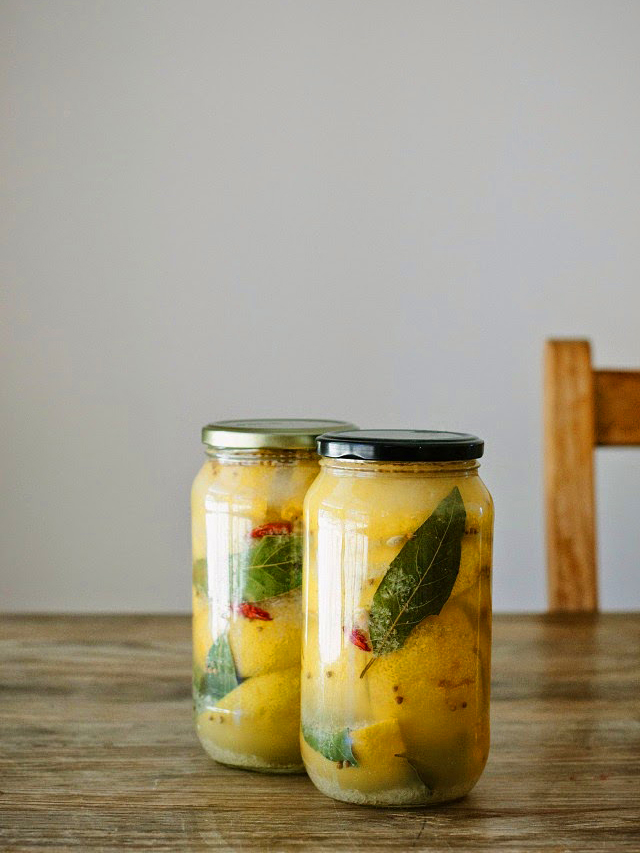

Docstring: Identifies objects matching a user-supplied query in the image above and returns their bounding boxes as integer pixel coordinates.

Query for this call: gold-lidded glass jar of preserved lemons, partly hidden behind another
[191,420,358,772]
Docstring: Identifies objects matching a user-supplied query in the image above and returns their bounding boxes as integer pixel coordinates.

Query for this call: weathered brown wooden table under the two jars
[0,614,640,853]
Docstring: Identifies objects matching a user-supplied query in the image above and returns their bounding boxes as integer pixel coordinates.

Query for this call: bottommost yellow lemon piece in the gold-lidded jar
[196,667,302,772]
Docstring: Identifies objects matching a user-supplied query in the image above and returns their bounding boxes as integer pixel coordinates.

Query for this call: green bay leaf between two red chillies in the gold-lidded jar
[232,535,302,602]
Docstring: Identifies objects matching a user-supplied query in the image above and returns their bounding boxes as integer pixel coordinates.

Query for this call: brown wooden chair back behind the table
[544,340,640,612]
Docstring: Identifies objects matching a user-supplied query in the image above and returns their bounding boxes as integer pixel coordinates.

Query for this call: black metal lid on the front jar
[318,429,484,462]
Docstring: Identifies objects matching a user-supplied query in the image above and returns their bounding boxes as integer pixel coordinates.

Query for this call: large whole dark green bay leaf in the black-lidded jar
[360,486,466,678]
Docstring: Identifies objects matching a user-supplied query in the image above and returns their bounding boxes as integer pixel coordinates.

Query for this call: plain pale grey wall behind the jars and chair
[0,0,640,611]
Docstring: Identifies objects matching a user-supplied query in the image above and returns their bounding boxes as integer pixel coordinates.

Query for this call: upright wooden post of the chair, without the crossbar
[544,341,598,612]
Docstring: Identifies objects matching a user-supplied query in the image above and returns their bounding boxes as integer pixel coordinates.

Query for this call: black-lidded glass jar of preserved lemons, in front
[301,430,493,806]
